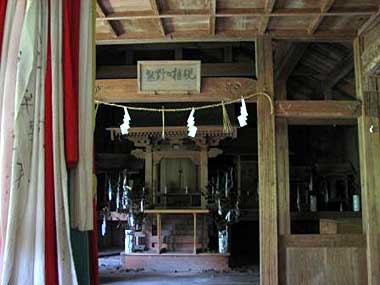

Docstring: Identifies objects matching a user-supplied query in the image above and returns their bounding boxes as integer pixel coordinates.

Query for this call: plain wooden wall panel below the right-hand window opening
[280,234,368,285]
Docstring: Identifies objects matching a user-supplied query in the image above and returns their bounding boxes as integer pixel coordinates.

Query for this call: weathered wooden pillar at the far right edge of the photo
[354,38,380,285]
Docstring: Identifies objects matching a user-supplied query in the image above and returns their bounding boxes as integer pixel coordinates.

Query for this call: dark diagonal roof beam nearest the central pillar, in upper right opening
[276,43,309,80]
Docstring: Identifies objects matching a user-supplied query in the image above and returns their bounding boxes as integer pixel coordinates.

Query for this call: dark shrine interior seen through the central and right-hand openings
[94,40,362,274]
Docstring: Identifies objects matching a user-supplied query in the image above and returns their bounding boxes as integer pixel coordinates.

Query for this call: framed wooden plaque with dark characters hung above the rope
[137,60,201,93]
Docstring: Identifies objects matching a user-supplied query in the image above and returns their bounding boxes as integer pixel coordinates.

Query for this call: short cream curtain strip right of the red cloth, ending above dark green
[70,0,94,231]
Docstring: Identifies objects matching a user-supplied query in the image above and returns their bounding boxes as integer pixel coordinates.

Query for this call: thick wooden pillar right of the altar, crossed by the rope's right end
[256,35,278,285]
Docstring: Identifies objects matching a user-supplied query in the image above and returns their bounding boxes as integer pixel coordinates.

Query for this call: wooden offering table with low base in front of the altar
[121,209,229,271]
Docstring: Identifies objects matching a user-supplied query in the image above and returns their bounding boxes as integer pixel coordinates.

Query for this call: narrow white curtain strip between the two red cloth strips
[50,0,77,285]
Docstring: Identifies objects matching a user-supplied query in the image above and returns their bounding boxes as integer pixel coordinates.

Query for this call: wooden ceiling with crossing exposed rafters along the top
[96,0,379,44]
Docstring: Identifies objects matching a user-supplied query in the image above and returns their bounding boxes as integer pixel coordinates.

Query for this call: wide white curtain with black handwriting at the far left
[1,0,47,284]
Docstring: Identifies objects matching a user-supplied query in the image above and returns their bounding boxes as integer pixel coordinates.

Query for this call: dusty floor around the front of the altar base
[99,256,259,285]
